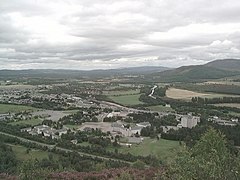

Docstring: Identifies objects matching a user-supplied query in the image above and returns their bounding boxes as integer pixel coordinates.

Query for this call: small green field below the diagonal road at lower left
[8,144,49,161]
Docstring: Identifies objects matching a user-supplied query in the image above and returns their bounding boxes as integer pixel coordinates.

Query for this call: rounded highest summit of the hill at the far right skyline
[205,59,240,71]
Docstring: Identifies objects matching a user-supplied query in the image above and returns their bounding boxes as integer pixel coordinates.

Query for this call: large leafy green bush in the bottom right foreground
[168,129,240,180]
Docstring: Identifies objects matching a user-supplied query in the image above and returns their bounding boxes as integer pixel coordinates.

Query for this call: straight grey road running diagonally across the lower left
[0,132,132,165]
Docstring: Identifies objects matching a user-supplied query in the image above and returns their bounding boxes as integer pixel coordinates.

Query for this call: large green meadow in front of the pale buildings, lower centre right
[116,138,180,162]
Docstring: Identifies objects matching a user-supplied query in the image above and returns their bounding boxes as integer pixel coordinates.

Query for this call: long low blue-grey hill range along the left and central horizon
[0,66,170,79]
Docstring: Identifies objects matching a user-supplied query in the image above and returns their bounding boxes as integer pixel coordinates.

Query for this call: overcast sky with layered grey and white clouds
[0,0,240,69]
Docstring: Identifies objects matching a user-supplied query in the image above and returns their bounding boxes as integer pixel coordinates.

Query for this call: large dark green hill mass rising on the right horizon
[147,60,240,82]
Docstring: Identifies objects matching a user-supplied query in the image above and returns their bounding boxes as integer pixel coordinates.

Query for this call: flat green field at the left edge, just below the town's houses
[0,104,37,113]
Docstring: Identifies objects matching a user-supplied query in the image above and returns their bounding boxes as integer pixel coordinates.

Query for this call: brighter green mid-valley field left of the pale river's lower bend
[108,94,143,106]
